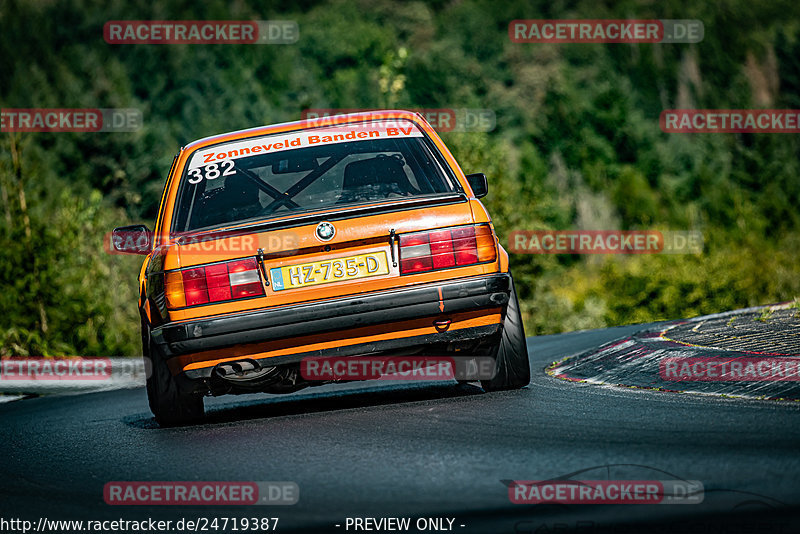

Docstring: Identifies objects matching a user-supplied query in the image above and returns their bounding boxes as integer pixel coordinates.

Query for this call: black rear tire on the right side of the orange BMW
[481,280,531,391]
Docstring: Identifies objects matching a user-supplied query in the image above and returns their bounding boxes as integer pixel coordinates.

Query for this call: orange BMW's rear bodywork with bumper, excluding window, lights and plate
[130,111,510,386]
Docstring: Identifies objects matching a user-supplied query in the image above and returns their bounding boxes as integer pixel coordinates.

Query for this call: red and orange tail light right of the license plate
[400,224,497,274]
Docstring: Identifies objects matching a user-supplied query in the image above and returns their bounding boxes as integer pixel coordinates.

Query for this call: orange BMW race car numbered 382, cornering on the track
[112,111,530,424]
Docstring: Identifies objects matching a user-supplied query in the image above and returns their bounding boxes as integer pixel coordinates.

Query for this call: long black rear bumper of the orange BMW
[151,274,511,374]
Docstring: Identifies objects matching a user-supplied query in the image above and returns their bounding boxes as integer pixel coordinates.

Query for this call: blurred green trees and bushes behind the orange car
[0,0,800,355]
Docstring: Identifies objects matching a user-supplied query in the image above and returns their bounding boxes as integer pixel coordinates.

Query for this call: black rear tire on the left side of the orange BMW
[142,330,203,426]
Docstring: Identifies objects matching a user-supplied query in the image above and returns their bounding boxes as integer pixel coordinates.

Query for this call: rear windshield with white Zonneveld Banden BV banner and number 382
[173,120,460,232]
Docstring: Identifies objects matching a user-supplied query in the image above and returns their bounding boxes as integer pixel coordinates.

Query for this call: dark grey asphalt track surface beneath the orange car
[0,325,800,534]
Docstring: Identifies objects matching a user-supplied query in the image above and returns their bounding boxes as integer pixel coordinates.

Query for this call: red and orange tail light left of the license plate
[164,258,264,308]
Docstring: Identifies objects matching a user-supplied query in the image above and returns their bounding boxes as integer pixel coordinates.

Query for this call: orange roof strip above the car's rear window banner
[183,110,433,154]
